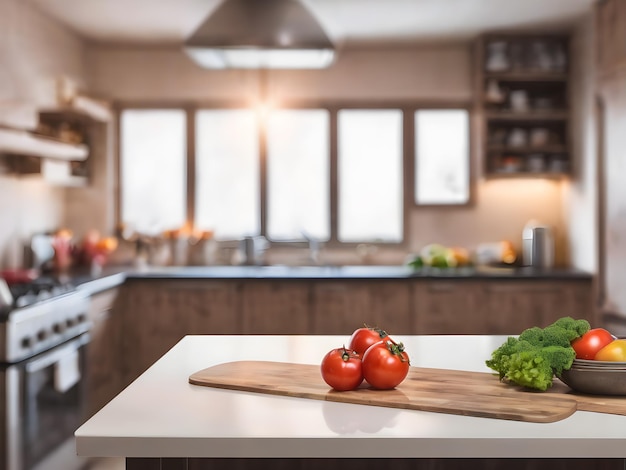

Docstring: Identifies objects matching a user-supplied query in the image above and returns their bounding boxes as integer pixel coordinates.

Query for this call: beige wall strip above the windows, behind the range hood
[89,44,472,102]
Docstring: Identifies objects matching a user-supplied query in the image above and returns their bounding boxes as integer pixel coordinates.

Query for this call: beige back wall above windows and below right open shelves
[89,39,567,263]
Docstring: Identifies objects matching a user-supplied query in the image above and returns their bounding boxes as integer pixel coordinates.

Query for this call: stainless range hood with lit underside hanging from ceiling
[184,0,335,69]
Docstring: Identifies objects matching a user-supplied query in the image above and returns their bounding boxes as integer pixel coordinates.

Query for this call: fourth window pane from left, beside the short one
[338,110,403,242]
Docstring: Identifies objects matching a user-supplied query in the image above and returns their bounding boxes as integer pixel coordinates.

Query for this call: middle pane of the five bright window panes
[267,110,330,240]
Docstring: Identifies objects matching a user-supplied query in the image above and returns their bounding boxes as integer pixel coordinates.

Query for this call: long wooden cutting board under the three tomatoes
[189,361,584,423]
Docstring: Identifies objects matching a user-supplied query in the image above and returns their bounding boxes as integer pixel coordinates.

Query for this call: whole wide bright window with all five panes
[120,104,470,246]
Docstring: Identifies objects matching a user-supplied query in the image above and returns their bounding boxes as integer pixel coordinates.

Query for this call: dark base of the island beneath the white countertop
[126,458,626,470]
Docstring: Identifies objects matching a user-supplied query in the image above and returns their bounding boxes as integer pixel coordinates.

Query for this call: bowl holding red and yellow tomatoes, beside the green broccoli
[558,328,626,395]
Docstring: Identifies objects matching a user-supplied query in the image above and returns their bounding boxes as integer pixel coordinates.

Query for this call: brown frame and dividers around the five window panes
[114,100,476,248]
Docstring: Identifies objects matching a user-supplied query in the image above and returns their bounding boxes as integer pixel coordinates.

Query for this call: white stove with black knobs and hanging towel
[0,278,91,470]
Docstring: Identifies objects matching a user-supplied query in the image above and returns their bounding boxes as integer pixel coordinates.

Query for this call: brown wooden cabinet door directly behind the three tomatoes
[311,280,415,335]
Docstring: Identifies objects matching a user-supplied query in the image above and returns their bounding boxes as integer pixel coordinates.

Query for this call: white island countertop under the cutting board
[76,335,626,458]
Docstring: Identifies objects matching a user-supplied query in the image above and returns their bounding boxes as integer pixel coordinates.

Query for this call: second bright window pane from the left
[195,109,260,240]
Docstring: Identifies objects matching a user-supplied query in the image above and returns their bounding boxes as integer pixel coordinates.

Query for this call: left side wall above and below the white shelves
[0,0,84,267]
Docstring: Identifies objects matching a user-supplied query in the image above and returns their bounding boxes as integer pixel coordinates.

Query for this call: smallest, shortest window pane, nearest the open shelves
[415,109,469,204]
